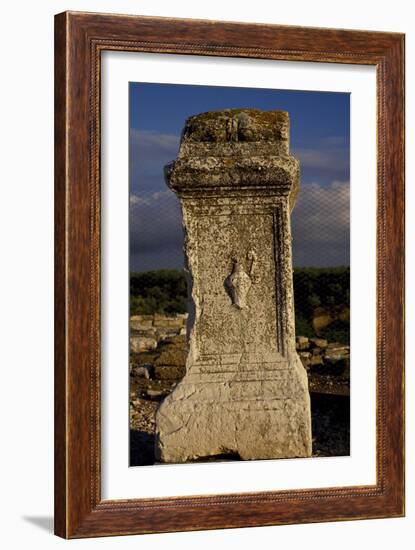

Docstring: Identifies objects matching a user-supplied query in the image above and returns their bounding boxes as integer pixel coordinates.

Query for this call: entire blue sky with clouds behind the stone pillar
[130,82,350,271]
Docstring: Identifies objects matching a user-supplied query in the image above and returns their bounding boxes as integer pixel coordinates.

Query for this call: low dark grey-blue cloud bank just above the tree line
[130,181,350,271]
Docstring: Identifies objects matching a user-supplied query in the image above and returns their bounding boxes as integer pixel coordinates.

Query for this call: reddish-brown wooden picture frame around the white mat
[55,12,404,538]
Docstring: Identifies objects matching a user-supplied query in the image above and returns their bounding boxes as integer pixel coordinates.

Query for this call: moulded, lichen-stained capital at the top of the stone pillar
[165,109,299,205]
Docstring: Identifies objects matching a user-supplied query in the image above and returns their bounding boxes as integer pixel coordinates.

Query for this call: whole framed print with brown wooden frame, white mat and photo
[55,12,404,538]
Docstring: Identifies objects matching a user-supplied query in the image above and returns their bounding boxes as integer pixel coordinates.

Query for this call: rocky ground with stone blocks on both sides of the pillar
[130,315,350,466]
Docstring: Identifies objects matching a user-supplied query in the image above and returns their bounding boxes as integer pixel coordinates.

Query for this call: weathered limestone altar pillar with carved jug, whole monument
[156,109,311,462]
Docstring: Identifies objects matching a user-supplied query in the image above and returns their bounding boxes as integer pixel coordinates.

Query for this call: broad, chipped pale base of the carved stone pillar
[156,354,311,463]
